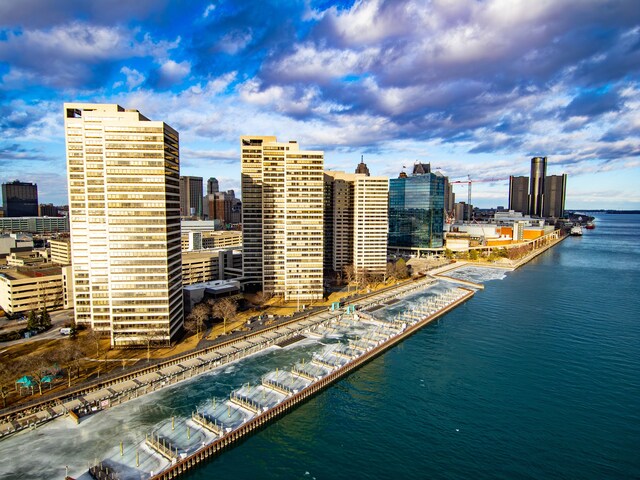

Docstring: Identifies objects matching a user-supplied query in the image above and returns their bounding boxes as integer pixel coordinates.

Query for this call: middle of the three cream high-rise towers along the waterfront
[240,136,324,300]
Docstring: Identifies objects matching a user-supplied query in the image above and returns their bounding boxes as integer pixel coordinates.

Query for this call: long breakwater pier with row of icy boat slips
[90,281,474,480]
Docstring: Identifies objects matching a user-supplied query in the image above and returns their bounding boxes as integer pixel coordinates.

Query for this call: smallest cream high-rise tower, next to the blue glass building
[324,171,389,275]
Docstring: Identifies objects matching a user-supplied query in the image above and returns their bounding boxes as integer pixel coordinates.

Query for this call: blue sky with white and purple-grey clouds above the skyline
[0,0,640,210]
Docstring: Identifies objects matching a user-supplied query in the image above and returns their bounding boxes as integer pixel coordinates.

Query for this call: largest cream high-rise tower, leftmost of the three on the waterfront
[64,103,183,347]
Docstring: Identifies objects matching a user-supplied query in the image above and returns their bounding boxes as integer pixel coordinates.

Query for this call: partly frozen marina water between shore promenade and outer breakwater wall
[0,280,464,478]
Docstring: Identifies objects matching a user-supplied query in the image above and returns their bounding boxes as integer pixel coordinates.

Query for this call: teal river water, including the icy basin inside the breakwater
[0,215,640,480]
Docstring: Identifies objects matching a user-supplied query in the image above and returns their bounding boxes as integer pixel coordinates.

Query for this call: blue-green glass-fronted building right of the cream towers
[389,169,444,249]
